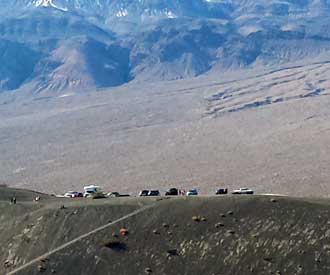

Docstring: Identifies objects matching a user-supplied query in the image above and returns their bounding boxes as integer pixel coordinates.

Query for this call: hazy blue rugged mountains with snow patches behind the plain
[0,0,330,95]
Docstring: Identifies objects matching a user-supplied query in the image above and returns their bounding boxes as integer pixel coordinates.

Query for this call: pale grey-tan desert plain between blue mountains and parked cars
[0,62,330,197]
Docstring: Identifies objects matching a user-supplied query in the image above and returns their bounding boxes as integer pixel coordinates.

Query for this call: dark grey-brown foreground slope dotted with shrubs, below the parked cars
[0,188,330,275]
